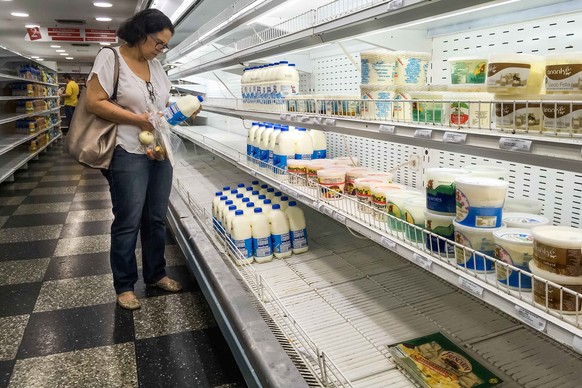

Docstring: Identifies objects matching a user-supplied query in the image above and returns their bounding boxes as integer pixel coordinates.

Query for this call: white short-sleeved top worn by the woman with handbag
[87,47,171,154]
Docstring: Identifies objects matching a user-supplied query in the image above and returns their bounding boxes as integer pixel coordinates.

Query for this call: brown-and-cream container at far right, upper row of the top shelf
[545,52,582,93]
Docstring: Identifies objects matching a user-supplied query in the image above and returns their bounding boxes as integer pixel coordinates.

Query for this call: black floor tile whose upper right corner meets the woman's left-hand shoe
[17,303,135,359]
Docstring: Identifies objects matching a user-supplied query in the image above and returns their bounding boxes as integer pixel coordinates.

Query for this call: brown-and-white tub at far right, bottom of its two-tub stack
[529,260,582,314]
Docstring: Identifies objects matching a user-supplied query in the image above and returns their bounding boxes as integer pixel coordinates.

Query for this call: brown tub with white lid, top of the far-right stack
[532,226,582,276]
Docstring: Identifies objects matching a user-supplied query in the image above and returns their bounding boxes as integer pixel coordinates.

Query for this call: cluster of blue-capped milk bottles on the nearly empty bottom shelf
[212,181,309,264]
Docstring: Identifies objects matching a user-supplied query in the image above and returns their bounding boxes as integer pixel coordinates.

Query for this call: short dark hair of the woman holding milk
[117,8,174,46]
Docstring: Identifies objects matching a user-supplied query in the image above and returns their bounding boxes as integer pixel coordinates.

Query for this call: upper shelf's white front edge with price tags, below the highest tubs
[204,100,582,172]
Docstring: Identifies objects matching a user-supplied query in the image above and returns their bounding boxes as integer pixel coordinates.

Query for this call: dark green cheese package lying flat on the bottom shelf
[388,333,502,388]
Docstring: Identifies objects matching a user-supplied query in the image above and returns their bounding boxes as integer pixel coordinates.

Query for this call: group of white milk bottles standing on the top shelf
[241,61,299,110]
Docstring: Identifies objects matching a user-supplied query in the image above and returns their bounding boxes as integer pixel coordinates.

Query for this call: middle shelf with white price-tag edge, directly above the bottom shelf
[175,126,582,353]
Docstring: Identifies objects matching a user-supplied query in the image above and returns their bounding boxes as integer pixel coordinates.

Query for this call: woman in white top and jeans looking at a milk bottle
[87,9,198,310]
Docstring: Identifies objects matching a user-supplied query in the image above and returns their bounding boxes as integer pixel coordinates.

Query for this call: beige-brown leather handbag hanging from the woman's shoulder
[65,47,119,169]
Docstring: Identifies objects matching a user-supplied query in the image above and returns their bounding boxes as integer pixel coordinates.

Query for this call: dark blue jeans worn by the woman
[103,146,173,294]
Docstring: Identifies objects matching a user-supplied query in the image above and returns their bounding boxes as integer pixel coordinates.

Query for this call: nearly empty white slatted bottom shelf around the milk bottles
[174,144,582,387]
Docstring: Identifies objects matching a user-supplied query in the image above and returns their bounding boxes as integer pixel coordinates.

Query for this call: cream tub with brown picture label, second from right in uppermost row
[487,53,545,94]
